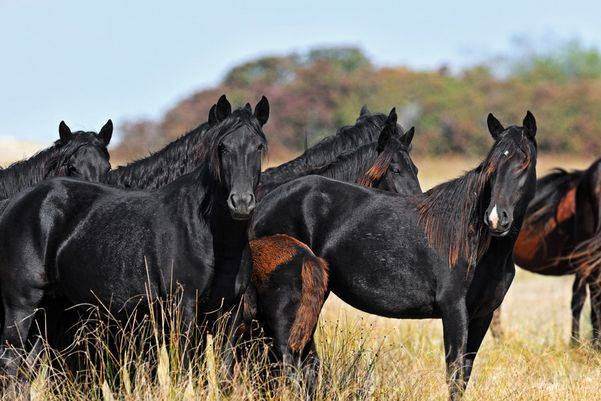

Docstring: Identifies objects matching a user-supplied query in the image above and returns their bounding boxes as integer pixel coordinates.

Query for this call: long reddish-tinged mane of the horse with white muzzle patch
[414,127,532,267]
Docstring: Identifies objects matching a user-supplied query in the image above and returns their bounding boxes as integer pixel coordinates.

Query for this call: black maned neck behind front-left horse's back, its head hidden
[103,123,208,189]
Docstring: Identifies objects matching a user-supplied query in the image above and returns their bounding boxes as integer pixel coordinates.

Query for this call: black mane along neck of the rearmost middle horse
[261,114,386,186]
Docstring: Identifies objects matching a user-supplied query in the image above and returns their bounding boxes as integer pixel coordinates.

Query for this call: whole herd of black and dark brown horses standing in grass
[0,95,601,399]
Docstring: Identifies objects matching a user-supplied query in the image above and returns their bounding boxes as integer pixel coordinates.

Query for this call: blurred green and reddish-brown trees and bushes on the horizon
[114,41,601,160]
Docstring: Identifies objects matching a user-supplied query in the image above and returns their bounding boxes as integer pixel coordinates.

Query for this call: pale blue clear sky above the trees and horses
[0,0,601,143]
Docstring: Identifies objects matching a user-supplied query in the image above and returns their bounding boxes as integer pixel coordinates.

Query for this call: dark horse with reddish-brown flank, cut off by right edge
[508,159,601,346]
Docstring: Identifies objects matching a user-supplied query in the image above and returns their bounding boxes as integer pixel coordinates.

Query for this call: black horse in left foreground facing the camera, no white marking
[0,98,269,374]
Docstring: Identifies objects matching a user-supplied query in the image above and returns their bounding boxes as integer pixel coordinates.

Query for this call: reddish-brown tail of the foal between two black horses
[288,250,328,352]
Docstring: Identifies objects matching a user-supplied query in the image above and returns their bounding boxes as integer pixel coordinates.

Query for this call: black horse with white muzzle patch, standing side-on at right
[245,112,537,399]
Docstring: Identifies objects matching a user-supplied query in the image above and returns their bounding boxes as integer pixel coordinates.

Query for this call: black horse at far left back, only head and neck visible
[0,120,113,199]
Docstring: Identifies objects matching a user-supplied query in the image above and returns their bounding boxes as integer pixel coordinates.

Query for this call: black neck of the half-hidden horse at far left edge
[0,145,60,199]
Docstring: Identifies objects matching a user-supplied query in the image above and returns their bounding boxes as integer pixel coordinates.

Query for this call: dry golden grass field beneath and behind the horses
[2,152,601,401]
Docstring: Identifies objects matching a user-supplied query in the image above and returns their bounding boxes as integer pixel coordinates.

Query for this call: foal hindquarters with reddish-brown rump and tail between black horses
[250,235,328,399]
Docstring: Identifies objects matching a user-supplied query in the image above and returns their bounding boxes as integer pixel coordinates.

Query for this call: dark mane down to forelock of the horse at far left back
[0,131,95,199]
